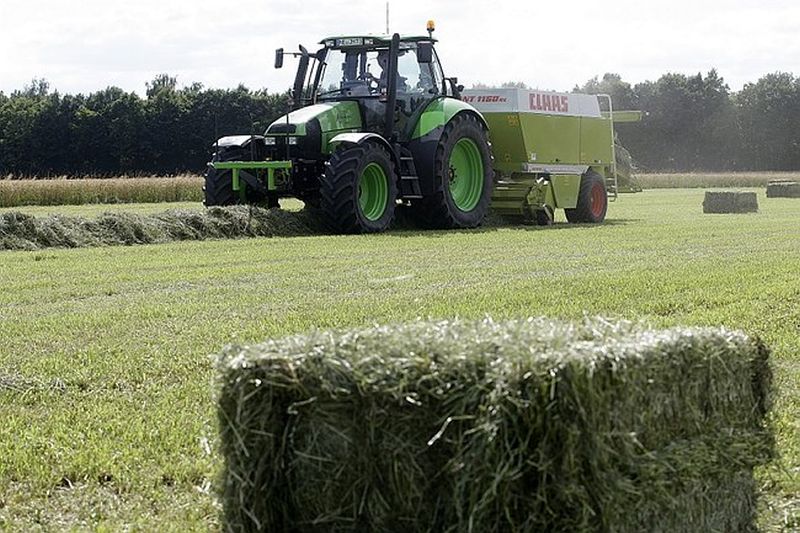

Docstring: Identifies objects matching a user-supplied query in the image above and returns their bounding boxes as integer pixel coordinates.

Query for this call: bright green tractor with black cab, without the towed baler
[204,23,494,233]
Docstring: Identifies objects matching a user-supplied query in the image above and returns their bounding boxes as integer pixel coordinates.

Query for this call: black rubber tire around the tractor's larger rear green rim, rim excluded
[411,113,494,229]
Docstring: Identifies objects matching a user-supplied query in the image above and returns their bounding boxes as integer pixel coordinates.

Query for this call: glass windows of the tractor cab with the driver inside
[317,44,441,100]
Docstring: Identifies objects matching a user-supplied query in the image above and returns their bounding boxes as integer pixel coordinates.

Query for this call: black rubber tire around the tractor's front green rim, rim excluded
[319,142,397,233]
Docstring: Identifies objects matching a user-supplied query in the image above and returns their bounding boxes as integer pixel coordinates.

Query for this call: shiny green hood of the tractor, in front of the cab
[266,101,361,136]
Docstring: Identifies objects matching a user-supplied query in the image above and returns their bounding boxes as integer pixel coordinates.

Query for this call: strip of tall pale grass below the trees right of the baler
[636,172,800,189]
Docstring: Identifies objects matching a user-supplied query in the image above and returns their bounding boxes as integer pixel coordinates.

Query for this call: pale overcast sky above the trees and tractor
[0,0,800,94]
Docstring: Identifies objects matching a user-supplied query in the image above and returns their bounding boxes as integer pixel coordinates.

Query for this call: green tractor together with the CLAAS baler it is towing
[204,23,636,232]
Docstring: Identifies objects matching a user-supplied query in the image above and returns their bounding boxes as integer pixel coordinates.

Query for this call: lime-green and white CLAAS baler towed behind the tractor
[462,88,638,224]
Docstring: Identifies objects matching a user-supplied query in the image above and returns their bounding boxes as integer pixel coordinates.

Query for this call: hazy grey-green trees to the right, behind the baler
[575,70,800,171]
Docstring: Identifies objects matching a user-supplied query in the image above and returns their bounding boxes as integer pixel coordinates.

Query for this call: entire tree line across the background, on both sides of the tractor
[0,70,800,175]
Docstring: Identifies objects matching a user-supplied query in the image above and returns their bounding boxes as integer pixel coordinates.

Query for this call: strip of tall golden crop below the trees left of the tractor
[0,176,203,207]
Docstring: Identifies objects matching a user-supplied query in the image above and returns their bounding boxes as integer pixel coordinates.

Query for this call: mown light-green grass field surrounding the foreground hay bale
[0,190,800,531]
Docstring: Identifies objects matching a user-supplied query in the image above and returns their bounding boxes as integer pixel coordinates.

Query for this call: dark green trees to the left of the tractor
[0,75,290,176]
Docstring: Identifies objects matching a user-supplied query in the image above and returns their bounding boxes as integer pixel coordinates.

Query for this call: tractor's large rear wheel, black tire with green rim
[412,114,494,229]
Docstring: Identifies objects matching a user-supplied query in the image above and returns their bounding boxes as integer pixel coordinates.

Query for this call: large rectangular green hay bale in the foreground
[218,319,773,532]
